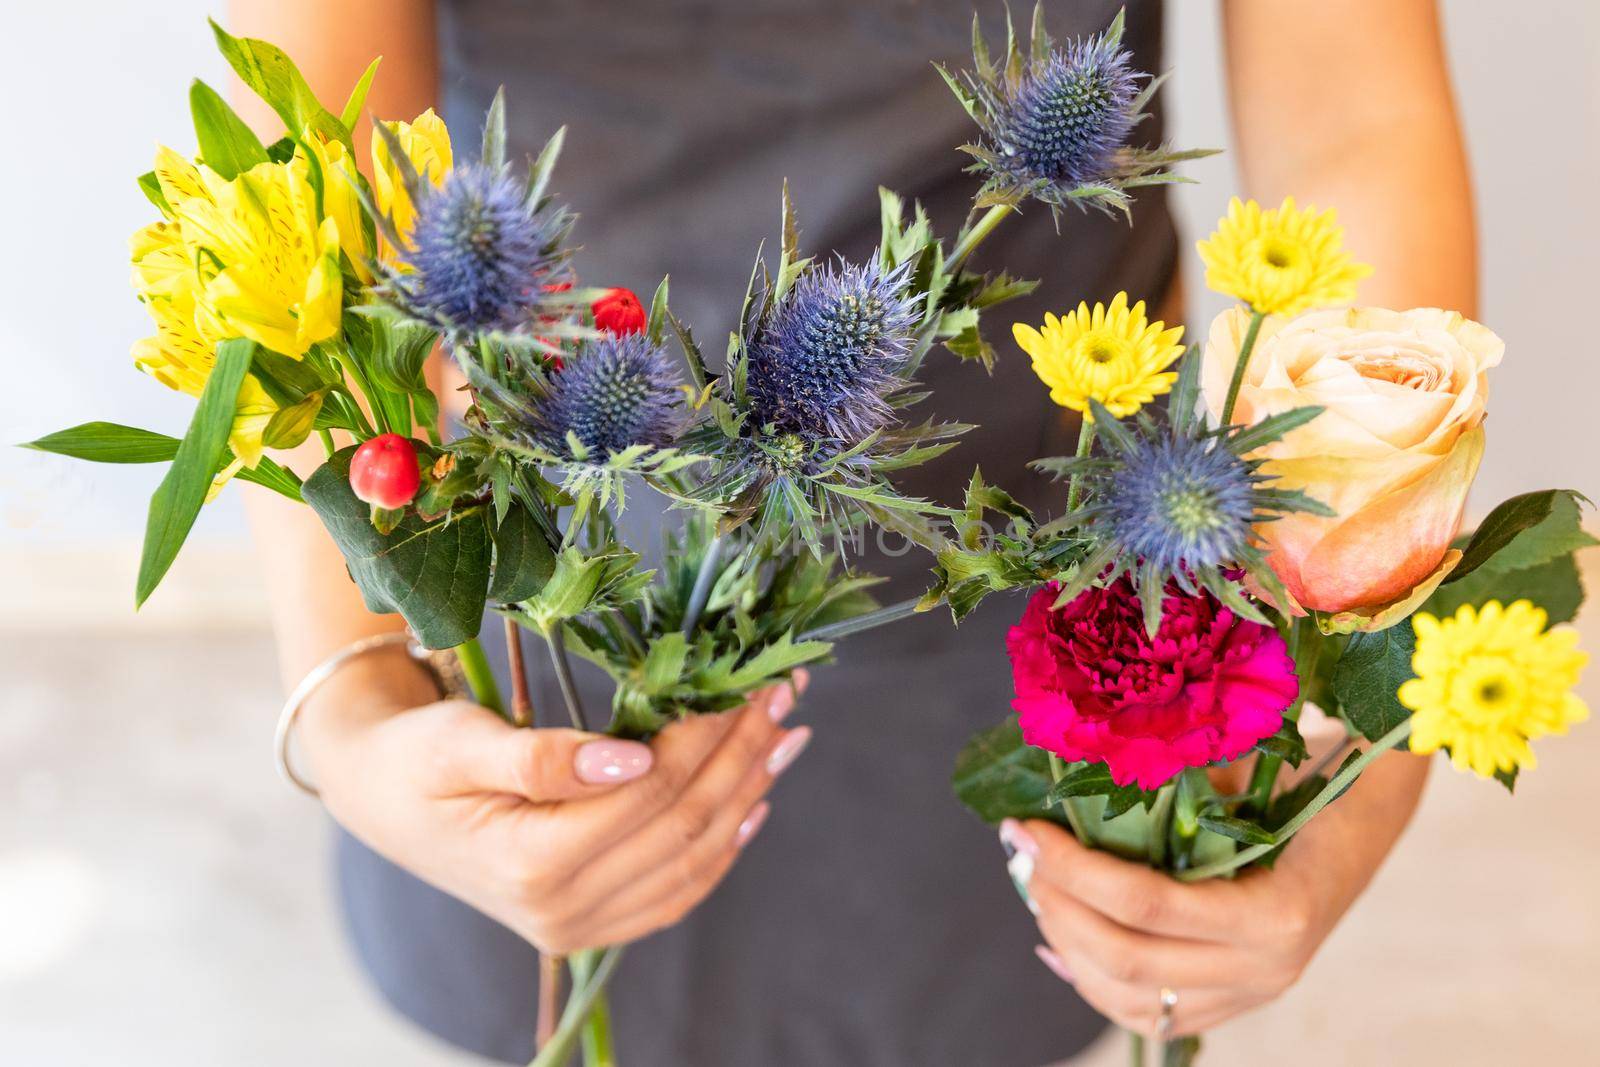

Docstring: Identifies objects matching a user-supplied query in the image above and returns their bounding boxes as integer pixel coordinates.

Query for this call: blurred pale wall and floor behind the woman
[0,0,1600,1064]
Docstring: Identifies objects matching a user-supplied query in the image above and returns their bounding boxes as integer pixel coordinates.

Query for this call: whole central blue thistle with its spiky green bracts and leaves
[672,189,1032,555]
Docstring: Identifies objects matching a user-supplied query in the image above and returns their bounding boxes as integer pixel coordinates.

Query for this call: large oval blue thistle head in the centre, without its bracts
[746,259,917,445]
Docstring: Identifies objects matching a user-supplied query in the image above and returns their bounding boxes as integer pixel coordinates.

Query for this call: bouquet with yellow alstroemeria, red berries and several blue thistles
[30,14,1216,1064]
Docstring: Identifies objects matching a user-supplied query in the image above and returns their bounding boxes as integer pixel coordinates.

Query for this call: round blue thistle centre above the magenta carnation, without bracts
[1106,435,1256,574]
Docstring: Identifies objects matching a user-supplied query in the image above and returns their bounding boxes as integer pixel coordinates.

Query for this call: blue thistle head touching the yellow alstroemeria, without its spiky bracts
[395,163,568,336]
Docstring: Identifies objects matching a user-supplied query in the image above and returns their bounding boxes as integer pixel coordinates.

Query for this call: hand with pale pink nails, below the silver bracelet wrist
[301,659,811,955]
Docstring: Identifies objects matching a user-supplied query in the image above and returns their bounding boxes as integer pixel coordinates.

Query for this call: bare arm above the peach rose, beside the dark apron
[1226,0,1477,315]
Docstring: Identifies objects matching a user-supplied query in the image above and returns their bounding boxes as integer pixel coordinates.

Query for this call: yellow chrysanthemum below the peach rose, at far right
[1398,600,1589,777]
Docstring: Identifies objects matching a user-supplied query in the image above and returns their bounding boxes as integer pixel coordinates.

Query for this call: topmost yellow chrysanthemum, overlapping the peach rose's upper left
[1197,197,1373,315]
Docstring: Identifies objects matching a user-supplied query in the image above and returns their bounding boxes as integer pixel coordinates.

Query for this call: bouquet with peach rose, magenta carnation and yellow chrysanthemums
[930,20,1595,1064]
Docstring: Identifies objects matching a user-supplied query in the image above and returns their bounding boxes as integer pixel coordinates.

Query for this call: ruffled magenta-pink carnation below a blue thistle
[1006,577,1299,789]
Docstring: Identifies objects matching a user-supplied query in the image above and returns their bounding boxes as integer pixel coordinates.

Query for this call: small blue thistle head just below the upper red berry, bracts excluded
[533,334,683,458]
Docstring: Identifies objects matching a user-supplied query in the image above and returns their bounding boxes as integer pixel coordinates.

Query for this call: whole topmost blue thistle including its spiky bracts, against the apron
[939,3,1213,214]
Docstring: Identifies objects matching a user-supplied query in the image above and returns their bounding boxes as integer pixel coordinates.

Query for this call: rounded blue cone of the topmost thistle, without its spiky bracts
[992,37,1147,186]
